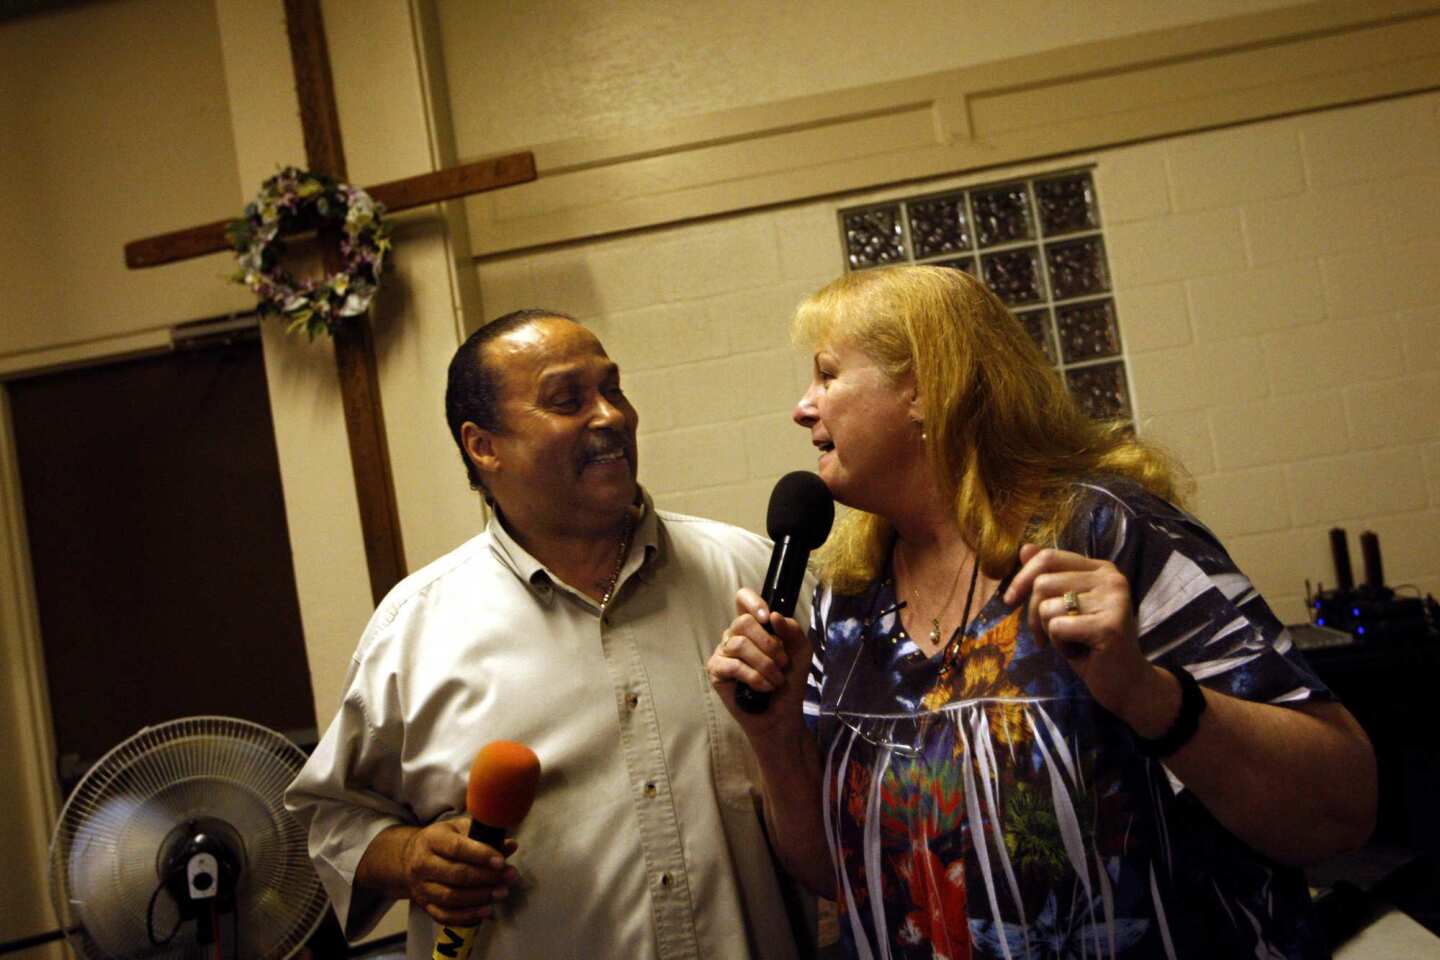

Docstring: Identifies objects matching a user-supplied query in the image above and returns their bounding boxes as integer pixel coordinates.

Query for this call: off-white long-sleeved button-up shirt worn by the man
[287,508,808,960]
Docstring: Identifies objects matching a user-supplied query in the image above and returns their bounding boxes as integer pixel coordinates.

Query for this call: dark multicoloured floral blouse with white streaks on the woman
[806,481,1329,960]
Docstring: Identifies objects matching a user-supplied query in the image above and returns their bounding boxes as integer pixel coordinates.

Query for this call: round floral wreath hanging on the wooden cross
[225,167,390,338]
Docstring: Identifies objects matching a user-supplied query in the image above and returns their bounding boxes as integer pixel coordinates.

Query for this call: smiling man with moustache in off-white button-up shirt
[287,311,808,960]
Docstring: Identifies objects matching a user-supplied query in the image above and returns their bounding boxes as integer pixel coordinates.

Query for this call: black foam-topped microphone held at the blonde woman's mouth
[734,471,835,714]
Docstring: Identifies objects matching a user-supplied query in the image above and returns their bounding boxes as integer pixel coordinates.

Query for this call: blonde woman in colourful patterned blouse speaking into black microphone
[708,266,1375,960]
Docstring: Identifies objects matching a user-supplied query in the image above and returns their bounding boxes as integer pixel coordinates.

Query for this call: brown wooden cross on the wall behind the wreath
[125,0,536,603]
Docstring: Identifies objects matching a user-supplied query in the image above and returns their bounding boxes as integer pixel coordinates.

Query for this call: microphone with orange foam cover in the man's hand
[432,740,540,960]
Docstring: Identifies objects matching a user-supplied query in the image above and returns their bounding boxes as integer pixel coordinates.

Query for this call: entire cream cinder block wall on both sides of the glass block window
[478,95,1440,620]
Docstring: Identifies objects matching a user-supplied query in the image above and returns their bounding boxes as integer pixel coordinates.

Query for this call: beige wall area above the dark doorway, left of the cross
[0,0,252,363]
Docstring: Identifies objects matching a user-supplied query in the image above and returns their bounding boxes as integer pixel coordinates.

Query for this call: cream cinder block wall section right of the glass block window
[1123,95,1440,620]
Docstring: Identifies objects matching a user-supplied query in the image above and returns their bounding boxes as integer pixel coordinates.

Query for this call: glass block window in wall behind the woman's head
[840,170,1133,420]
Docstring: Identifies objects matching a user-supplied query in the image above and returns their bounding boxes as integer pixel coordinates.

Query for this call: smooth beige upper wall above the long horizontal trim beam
[436,0,1299,157]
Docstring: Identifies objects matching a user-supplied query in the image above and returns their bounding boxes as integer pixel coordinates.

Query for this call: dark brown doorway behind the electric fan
[7,330,315,793]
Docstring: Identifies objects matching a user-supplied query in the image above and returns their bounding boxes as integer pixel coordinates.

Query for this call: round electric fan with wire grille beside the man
[50,717,327,960]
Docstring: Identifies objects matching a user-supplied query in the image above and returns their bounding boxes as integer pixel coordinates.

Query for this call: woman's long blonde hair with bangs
[792,266,1184,593]
